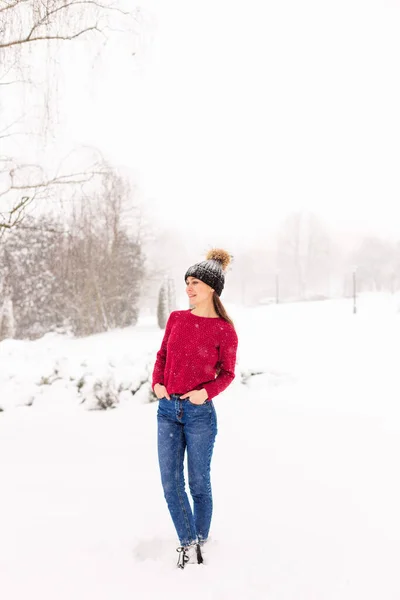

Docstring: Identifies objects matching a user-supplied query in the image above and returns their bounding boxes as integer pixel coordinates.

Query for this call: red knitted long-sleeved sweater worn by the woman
[152,309,238,400]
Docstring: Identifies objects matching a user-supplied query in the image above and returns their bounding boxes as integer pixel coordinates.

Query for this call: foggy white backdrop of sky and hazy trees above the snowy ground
[0,0,400,337]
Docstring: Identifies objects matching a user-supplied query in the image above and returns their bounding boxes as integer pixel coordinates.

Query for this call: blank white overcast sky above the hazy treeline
[55,0,400,243]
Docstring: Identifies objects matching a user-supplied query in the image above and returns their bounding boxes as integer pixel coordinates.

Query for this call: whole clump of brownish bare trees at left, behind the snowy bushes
[0,168,144,338]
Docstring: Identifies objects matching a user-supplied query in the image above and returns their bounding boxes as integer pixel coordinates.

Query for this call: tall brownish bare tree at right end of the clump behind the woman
[58,172,144,335]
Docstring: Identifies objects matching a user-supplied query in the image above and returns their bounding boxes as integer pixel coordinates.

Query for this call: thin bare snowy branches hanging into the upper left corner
[0,0,138,234]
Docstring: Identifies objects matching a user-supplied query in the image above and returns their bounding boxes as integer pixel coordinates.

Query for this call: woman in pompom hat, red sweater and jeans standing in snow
[152,249,238,569]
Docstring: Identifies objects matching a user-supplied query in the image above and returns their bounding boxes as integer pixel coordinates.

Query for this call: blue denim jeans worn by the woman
[157,394,217,546]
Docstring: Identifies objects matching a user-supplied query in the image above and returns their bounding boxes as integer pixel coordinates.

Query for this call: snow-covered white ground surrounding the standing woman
[0,295,400,600]
